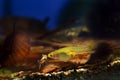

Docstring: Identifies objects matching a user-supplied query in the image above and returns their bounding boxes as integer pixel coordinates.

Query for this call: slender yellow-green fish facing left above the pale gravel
[47,46,94,62]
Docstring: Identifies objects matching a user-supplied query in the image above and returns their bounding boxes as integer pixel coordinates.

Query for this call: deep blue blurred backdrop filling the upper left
[0,0,69,29]
